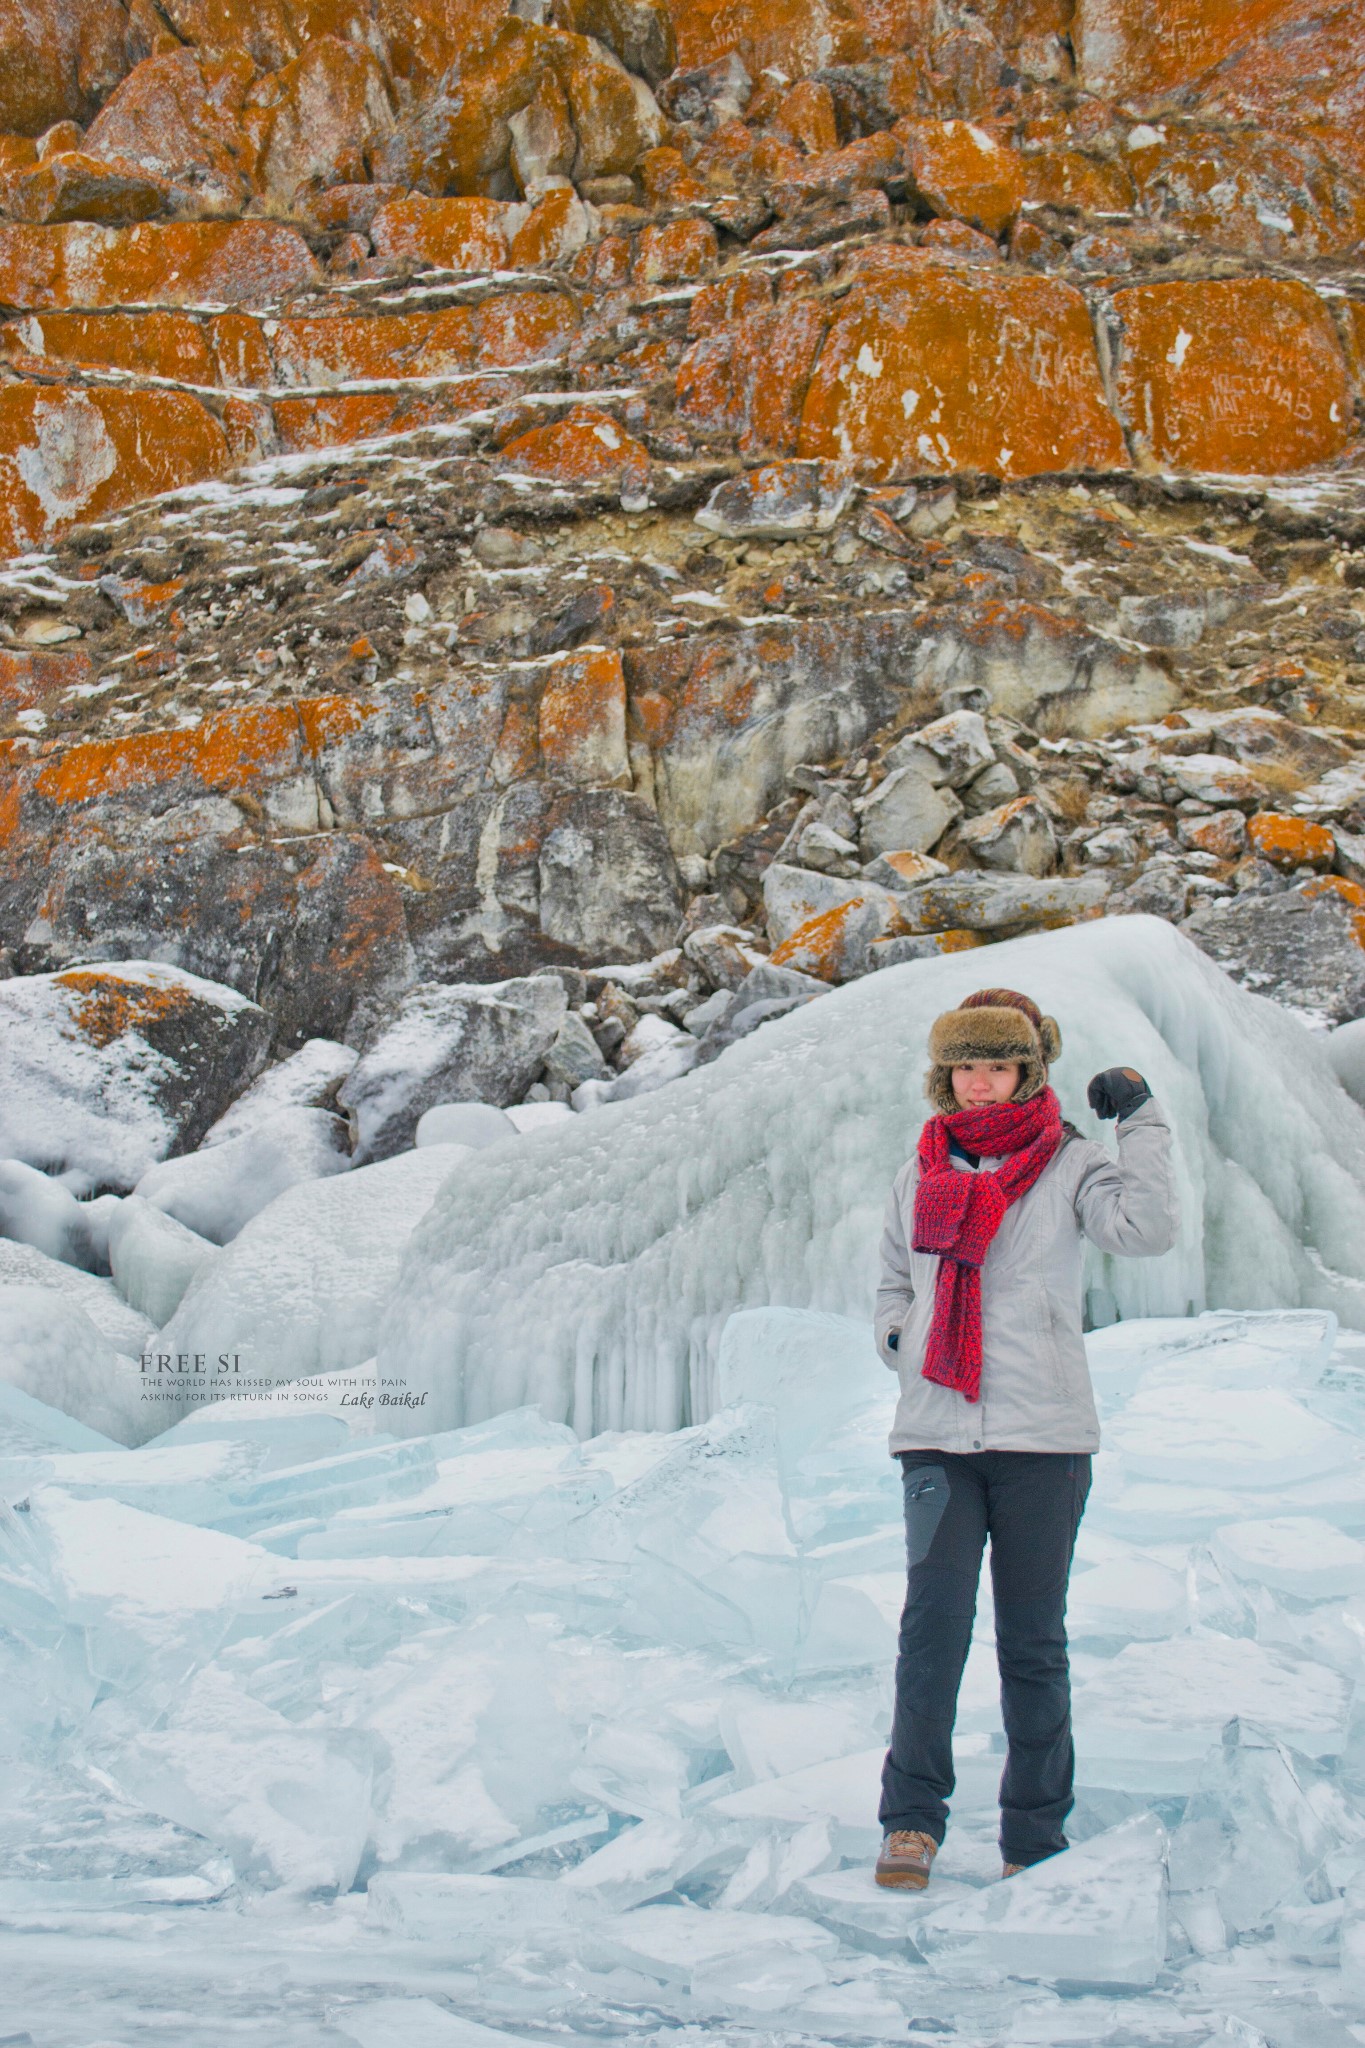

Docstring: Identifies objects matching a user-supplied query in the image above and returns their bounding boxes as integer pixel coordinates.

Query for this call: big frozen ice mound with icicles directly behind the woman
[379,918,1365,1436]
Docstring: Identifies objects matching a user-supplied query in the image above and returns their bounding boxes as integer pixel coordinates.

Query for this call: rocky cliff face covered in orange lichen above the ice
[0,0,1365,1096]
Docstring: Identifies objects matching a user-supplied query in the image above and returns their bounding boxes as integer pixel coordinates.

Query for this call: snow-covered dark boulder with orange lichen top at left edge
[0,961,270,1188]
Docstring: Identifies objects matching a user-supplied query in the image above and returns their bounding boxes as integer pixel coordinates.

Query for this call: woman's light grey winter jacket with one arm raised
[876,1100,1179,1454]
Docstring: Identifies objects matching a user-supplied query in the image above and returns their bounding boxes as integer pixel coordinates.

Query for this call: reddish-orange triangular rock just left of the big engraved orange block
[677,281,831,455]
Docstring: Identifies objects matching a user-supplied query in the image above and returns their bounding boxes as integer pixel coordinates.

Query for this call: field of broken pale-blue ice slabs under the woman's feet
[0,1309,1365,2048]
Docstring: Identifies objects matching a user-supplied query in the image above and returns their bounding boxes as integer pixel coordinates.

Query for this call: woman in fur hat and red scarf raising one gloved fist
[876,989,1179,1890]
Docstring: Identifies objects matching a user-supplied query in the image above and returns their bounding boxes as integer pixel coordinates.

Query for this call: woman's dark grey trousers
[880,1450,1091,1864]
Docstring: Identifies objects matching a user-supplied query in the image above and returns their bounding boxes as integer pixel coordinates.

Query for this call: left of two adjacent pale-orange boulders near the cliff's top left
[84,49,252,213]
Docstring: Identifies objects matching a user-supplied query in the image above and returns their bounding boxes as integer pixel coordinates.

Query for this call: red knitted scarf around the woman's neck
[915,1087,1062,1401]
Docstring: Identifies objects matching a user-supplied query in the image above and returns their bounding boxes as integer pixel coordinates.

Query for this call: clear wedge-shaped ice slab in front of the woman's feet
[915,1815,1166,1987]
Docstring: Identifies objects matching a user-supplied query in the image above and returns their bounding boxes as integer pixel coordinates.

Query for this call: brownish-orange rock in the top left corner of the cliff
[0,0,129,135]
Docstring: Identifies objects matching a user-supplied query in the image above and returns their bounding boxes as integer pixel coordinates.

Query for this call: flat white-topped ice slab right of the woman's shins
[1072,1634,1351,1794]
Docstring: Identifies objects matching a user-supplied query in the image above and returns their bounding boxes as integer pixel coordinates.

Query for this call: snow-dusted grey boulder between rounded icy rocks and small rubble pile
[347,975,567,1161]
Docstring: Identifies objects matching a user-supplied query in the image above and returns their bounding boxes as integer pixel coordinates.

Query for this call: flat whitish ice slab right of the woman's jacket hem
[1105,1382,1359,1491]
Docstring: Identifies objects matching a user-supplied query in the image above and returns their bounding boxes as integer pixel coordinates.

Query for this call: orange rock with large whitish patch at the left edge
[0,383,229,555]
